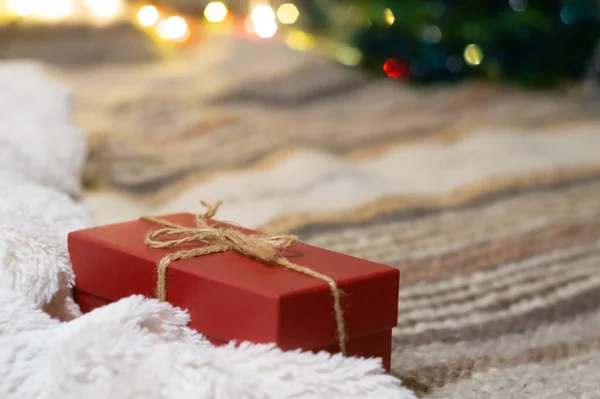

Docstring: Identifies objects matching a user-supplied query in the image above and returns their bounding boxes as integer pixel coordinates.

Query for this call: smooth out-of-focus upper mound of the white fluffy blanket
[0,61,87,196]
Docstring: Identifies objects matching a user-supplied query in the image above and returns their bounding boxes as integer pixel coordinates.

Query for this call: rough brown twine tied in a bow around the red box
[142,201,347,355]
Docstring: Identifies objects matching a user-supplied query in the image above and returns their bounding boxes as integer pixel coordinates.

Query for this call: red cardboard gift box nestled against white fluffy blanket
[68,213,400,370]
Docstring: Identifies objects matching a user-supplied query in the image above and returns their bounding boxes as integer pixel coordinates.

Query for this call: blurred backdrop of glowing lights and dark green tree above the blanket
[0,0,600,87]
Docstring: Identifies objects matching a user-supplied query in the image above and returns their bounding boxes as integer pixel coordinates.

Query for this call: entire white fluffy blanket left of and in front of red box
[0,63,414,399]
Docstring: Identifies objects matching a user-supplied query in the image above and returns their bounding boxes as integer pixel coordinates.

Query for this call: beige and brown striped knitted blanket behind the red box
[56,39,600,399]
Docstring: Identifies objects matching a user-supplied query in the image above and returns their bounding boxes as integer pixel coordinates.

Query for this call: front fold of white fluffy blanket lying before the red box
[0,291,412,399]
